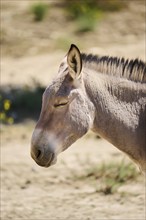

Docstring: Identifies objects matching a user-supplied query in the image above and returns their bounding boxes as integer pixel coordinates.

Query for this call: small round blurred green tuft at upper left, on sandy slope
[31,2,48,21]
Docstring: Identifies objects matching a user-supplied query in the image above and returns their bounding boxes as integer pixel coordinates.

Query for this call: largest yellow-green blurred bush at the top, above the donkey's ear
[64,0,126,32]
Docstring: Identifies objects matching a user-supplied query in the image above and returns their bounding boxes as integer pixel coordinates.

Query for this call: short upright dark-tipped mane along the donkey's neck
[81,53,146,83]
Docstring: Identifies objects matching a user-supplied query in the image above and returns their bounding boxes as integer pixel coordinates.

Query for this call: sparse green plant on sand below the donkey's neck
[72,158,139,195]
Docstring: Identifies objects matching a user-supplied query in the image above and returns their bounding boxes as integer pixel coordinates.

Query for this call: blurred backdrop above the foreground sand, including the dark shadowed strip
[0,0,145,123]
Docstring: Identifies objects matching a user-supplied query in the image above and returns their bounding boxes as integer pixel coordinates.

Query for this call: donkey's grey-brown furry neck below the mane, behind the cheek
[83,68,146,163]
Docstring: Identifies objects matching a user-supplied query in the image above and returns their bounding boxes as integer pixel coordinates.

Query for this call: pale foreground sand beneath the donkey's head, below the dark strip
[1,122,146,220]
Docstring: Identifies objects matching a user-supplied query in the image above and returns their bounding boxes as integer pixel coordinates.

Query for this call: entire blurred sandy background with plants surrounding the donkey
[0,0,146,220]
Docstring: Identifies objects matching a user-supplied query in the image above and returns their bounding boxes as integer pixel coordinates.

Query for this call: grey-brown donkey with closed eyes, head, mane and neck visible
[31,44,146,171]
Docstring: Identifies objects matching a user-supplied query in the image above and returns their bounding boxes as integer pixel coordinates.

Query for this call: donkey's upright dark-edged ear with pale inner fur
[67,44,82,79]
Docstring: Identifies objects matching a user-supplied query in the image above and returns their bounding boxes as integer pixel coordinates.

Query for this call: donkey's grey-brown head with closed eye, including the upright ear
[31,45,92,167]
